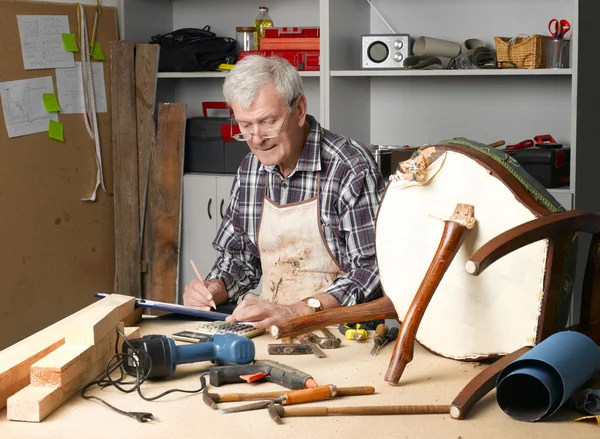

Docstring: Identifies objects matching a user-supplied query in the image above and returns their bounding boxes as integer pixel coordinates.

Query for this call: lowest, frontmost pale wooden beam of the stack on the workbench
[7,324,123,422]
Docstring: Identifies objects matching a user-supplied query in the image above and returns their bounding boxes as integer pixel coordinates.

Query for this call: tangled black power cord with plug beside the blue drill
[80,328,208,422]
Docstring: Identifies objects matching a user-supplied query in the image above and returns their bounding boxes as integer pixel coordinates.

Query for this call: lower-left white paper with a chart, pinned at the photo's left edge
[0,76,58,137]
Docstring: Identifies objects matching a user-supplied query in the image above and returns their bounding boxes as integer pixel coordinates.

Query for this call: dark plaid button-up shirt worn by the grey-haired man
[207,115,385,306]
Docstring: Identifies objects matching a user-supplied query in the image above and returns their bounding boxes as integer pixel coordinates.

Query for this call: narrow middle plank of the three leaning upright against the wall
[135,44,160,296]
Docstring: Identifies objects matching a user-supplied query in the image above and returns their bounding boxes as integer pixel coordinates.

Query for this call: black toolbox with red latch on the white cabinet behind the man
[183,117,250,174]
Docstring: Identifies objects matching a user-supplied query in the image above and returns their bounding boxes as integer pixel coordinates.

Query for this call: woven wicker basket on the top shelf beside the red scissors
[494,35,551,69]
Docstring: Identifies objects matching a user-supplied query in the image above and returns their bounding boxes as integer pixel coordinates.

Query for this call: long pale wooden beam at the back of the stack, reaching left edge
[0,294,135,408]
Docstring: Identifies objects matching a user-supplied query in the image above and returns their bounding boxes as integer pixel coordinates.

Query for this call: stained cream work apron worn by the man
[257,175,344,304]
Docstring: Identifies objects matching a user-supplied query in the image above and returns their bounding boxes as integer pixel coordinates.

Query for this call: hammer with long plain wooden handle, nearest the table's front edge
[268,401,450,424]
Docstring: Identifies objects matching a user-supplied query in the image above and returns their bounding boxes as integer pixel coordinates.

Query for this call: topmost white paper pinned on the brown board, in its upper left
[17,15,75,70]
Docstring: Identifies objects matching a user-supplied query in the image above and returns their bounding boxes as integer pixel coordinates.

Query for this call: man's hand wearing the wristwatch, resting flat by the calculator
[226,298,311,328]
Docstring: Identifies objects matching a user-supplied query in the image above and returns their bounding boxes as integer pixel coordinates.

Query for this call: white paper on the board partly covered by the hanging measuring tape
[56,62,108,114]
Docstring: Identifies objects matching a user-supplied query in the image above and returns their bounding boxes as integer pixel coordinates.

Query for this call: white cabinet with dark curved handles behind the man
[179,174,234,298]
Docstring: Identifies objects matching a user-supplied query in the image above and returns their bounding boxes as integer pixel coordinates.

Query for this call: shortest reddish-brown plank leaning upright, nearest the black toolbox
[146,103,186,303]
